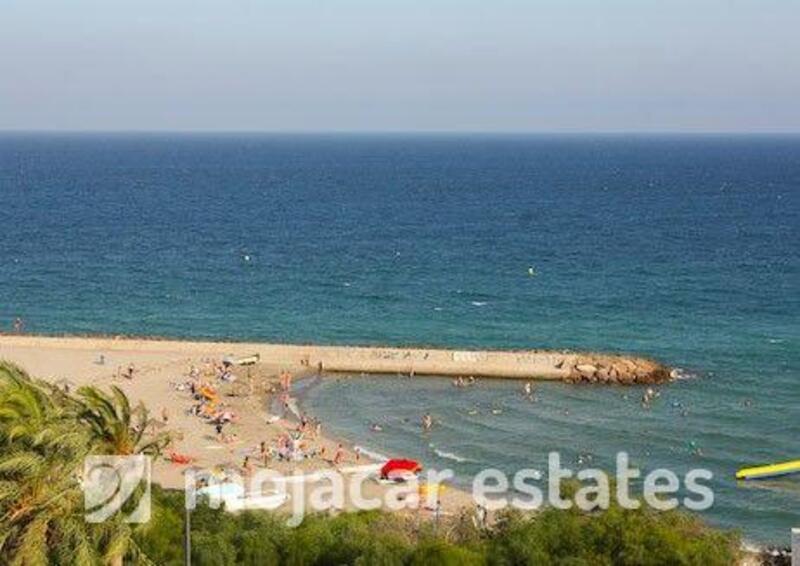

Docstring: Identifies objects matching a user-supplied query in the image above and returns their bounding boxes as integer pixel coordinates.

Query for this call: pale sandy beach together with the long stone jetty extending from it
[0,334,666,514]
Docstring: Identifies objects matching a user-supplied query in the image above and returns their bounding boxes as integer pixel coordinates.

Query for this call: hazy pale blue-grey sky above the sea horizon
[0,0,800,132]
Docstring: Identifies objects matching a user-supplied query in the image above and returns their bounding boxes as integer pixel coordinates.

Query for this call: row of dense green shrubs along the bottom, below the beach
[135,488,739,566]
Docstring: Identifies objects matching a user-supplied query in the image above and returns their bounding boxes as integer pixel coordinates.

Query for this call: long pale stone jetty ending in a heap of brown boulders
[0,335,674,384]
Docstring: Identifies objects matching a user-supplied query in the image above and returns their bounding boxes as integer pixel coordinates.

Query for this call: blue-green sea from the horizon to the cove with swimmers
[0,134,800,543]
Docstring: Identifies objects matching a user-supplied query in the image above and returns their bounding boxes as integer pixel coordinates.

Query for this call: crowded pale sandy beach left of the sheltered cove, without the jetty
[0,336,482,514]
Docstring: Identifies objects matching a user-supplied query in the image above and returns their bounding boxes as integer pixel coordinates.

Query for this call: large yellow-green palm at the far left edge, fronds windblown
[0,364,103,565]
